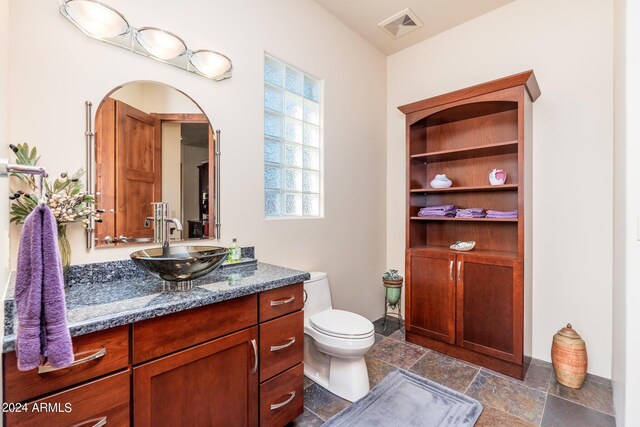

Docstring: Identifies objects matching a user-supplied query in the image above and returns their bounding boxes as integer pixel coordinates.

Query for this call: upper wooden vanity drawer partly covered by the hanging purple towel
[4,325,129,403]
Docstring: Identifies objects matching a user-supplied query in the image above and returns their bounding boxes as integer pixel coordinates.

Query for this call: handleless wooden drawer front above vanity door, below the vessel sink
[133,295,258,364]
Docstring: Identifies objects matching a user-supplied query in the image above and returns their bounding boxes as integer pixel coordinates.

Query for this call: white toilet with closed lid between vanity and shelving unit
[304,272,375,402]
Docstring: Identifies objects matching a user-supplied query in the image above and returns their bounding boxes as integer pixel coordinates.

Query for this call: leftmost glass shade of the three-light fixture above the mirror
[64,0,129,38]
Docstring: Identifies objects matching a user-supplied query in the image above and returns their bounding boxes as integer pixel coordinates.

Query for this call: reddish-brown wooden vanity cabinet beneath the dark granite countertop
[3,283,304,427]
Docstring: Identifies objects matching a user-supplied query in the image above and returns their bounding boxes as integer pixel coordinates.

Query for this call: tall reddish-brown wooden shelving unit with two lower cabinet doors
[399,71,540,379]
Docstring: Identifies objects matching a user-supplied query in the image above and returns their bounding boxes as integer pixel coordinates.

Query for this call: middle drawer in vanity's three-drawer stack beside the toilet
[260,311,304,381]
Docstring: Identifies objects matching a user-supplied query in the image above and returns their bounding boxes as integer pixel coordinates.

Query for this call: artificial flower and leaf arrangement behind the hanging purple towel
[9,143,101,267]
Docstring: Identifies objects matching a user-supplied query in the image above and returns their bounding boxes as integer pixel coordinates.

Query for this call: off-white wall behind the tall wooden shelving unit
[387,0,613,377]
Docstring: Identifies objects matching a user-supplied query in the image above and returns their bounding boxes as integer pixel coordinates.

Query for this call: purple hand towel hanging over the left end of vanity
[15,206,73,371]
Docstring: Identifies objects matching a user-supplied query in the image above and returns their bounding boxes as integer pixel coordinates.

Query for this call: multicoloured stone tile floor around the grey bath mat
[289,319,615,427]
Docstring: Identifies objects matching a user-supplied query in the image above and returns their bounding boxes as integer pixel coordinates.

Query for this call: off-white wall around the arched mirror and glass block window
[6,0,386,318]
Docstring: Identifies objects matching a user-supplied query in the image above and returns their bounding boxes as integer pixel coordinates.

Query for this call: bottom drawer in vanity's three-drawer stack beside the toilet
[260,363,304,426]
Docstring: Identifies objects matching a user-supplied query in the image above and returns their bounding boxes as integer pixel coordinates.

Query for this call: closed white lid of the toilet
[309,310,373,338]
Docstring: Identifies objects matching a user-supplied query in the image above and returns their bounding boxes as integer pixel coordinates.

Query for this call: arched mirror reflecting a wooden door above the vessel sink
[95,82,219,247]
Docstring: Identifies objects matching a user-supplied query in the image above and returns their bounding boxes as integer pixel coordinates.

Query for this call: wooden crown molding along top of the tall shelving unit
[398,70,540,114]
